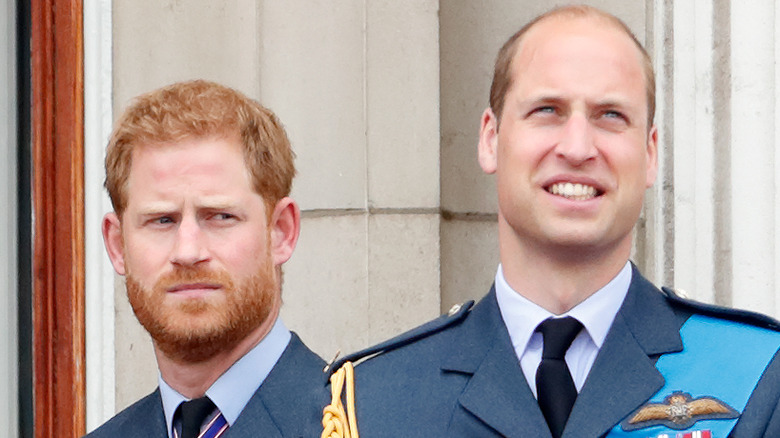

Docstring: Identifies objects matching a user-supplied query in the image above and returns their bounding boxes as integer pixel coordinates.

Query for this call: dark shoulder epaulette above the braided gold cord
[324,301,474,377]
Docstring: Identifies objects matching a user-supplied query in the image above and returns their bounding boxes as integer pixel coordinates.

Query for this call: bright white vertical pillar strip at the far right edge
[723,0,777,313]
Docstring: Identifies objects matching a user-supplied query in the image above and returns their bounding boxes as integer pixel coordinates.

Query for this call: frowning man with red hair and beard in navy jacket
[89,81,327,438]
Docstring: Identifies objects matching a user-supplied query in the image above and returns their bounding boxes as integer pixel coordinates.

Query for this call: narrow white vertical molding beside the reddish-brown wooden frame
[84,0,116,431]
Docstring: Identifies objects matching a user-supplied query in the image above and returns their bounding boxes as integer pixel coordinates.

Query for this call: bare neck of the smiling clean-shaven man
[499,222,631,315]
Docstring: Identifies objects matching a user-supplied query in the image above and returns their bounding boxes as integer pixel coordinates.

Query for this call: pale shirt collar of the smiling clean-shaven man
[495,262,632,351]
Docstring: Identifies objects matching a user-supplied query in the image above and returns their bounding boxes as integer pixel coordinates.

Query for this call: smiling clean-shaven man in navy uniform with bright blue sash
[326,6,780,438]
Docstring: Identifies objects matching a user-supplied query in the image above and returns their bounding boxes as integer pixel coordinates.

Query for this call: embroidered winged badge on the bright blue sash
[620,391,739,431]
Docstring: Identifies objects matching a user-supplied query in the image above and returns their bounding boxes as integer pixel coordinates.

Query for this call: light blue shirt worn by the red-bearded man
[158,318,292,438]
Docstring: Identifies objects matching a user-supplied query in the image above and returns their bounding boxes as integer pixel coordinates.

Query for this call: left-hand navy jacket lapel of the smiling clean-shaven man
[442,289,549,437]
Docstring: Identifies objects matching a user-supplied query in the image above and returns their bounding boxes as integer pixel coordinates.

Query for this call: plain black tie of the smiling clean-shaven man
[536,316,582,438]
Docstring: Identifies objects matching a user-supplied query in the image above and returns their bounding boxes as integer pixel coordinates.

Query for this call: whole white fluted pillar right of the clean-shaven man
[650,0,780,316]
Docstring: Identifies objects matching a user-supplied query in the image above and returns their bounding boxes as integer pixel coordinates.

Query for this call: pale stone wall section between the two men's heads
[260,0,439,359]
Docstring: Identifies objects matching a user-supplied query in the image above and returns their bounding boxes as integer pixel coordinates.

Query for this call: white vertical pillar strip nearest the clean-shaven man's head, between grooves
[667,0,715,302]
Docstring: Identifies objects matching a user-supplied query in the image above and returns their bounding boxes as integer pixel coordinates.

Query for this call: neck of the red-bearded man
[154,309,279,399]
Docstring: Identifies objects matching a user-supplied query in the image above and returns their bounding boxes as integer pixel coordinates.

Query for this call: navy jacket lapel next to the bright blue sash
[563,267,684,438]
